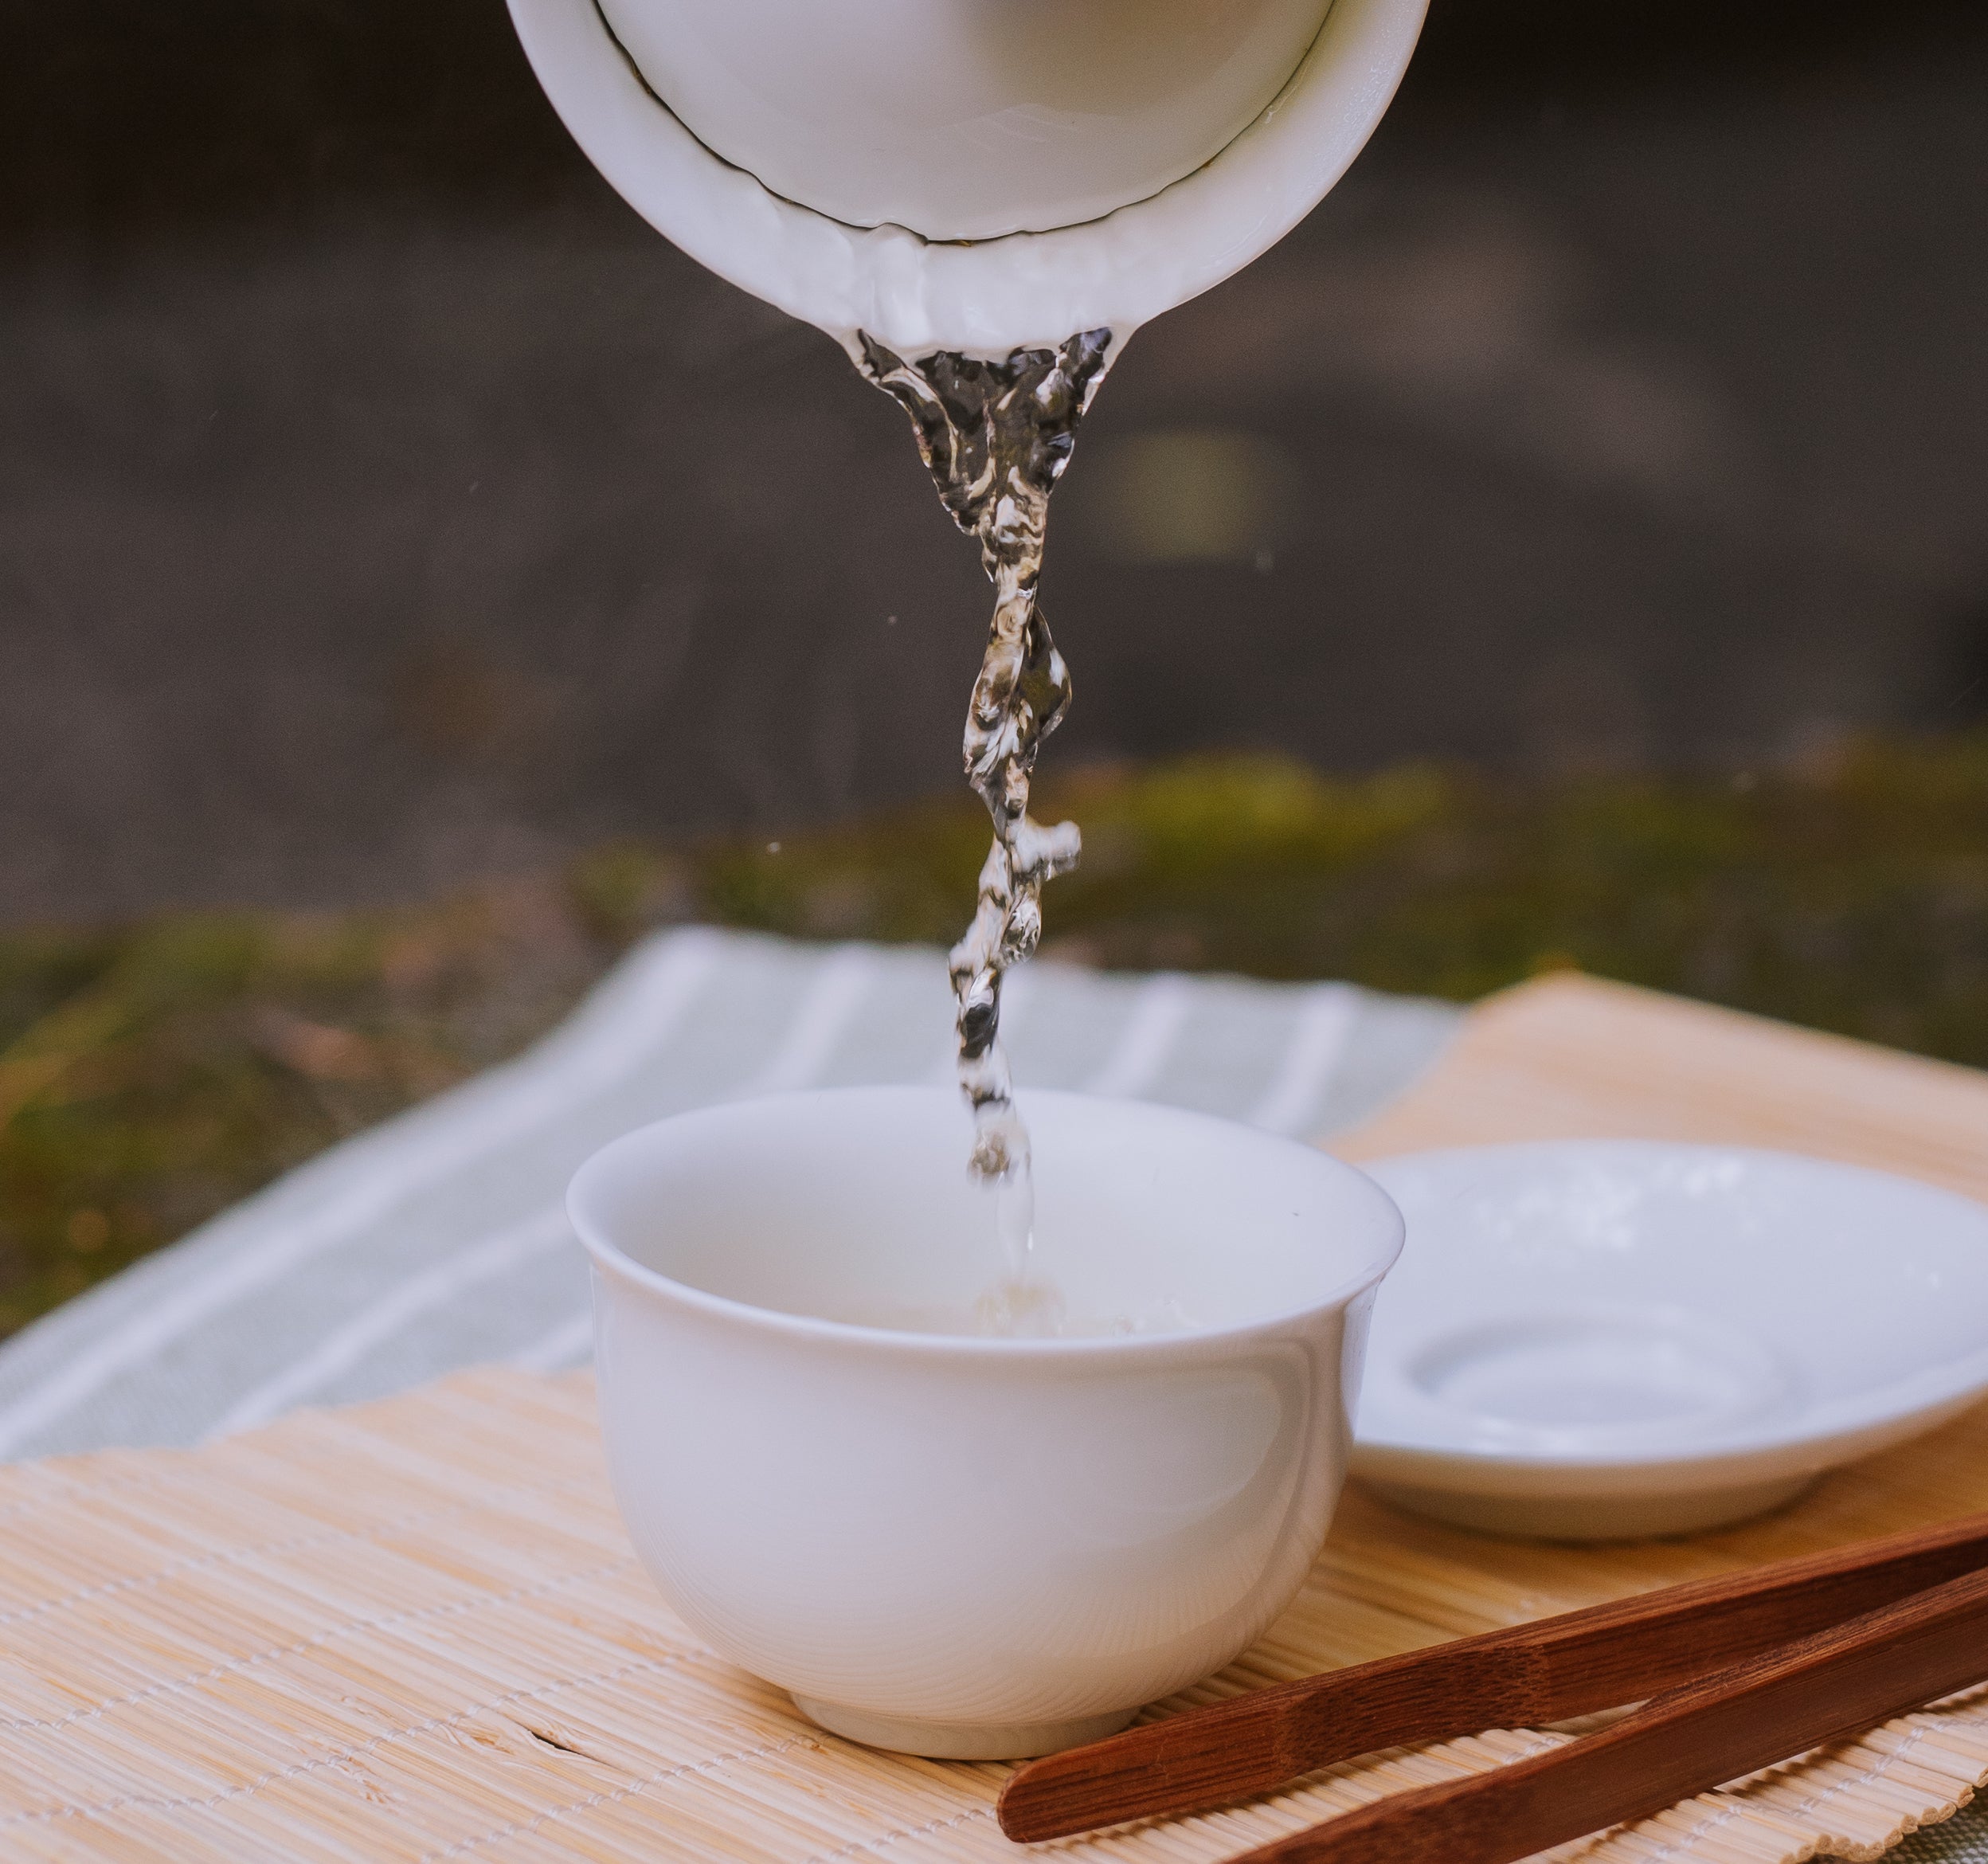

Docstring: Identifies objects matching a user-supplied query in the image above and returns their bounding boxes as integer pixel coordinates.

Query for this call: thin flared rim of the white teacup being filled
[566,1083,1407,1359]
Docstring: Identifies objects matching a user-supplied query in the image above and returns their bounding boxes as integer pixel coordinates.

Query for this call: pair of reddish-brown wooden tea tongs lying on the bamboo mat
[1000,1514,1988,1864]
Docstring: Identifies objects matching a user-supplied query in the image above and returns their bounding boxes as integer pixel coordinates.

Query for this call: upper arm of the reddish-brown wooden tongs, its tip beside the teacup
[1000,1514,1988,1842]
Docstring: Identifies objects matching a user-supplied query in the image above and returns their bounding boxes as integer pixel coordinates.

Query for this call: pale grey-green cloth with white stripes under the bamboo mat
[0,926,1458,1457]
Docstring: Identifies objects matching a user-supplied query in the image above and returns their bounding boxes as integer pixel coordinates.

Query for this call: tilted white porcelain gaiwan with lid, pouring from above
[511,0,1427,358]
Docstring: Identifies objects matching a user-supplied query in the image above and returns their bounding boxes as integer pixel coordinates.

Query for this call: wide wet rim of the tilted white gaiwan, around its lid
[497,0,1427,358]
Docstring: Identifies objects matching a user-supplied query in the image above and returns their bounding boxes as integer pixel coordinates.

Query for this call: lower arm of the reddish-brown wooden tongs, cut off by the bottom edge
[1235,1570,1988,1864]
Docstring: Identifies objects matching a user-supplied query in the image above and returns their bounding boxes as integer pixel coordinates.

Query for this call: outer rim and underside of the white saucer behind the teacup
[1352,1137,1988,1496]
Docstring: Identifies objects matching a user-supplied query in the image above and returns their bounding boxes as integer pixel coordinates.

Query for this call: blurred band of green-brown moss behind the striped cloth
[0,738,1988,1331]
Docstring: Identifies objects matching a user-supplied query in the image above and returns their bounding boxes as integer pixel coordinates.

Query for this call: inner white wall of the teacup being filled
[586,1089,1399,1333]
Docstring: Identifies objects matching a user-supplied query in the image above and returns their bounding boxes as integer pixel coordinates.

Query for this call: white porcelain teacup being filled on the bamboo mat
[570,1087,1399,1756]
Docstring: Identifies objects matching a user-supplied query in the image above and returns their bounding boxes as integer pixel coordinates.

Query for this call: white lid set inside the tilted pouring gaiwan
[601,0,1326,241]
